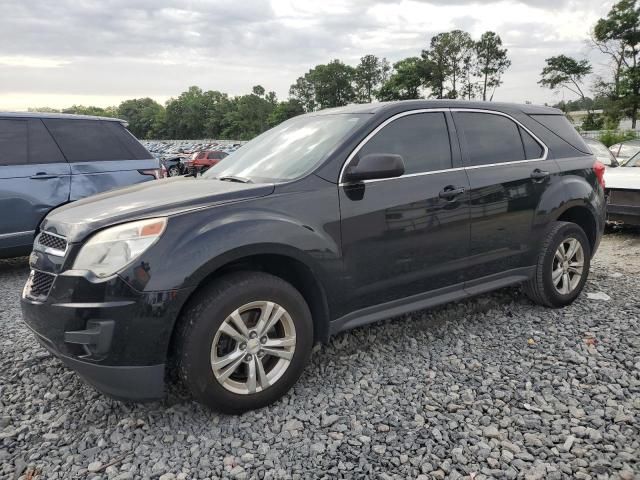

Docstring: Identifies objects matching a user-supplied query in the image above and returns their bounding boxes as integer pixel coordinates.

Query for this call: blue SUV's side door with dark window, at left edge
[0,118,70,250]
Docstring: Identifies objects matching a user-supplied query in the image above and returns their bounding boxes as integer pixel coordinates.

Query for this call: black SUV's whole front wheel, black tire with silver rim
[174,272,313,413]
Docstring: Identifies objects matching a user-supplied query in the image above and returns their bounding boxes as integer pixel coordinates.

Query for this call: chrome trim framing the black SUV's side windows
[338,108,549,187]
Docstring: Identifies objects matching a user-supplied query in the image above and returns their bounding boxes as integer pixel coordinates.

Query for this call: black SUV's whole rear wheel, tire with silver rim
[523,222,591,308]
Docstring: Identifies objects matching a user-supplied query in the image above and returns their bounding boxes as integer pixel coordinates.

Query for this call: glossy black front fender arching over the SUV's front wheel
[121,186,342,298]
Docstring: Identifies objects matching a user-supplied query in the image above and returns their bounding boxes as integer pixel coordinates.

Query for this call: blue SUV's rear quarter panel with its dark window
[44,118,160,200]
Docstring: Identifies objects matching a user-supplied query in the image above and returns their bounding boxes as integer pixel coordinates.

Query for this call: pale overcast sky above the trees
[0,0,613,110]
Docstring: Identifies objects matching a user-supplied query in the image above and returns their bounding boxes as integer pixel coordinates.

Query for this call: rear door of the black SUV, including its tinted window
[453,109,558,281]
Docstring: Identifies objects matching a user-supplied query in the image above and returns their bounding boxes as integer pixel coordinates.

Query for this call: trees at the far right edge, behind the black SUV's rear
[538,0,640,130]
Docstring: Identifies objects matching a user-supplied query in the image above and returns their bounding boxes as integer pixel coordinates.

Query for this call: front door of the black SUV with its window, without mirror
[336,111,469,315]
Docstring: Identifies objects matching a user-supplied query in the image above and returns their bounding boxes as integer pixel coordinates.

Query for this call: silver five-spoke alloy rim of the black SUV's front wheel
[211,301,296,395]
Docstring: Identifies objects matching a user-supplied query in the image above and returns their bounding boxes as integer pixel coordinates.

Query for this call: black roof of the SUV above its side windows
[311,100,564,115]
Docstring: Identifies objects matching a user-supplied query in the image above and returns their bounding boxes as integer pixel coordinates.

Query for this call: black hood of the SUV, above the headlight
[41,177,274,243]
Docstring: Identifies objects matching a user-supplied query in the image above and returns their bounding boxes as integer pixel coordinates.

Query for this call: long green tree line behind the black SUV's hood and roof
[30,30,511,140]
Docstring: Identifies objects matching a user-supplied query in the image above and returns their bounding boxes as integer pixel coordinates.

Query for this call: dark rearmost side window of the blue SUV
[43,118,135,162]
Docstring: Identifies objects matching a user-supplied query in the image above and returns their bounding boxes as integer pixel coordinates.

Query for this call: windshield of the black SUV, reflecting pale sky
[202,113,368,183]
